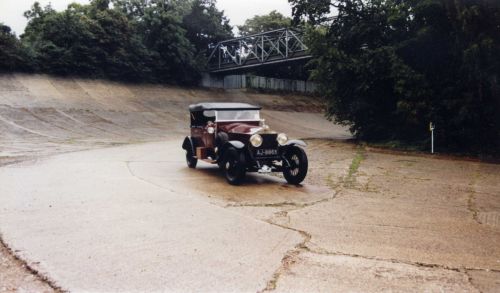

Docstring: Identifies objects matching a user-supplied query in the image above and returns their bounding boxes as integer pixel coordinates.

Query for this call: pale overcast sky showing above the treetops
[0,0,292,35]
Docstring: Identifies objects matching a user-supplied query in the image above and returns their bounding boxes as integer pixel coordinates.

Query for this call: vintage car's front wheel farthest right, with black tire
[283,146,309,185]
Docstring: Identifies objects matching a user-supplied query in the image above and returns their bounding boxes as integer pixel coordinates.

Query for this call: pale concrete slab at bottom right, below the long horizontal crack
[268,252,477,292]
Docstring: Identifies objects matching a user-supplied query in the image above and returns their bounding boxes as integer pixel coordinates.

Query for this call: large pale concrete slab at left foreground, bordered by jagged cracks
[0,141,301,292]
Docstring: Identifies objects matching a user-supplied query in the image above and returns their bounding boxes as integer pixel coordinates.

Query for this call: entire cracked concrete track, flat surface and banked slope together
[0,75,500,292]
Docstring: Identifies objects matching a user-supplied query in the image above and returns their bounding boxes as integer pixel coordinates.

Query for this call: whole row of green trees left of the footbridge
[0,0,232,84]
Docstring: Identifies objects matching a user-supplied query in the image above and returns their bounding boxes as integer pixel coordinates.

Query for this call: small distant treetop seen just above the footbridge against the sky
[238,10,292,35]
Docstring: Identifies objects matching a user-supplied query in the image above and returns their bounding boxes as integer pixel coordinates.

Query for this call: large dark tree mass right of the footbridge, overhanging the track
[290,0,500,152]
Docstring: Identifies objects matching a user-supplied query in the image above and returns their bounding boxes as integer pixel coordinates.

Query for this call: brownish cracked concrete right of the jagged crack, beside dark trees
[262,147,500,292]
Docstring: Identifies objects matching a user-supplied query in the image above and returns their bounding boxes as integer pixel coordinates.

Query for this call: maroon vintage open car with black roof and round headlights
[182,103,308,185]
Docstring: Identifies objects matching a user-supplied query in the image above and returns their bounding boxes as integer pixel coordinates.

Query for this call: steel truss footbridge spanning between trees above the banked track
[208,29,311,73]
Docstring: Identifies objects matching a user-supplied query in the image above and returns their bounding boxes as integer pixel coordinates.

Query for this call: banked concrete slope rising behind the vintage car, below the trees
[0,75,347,162]
